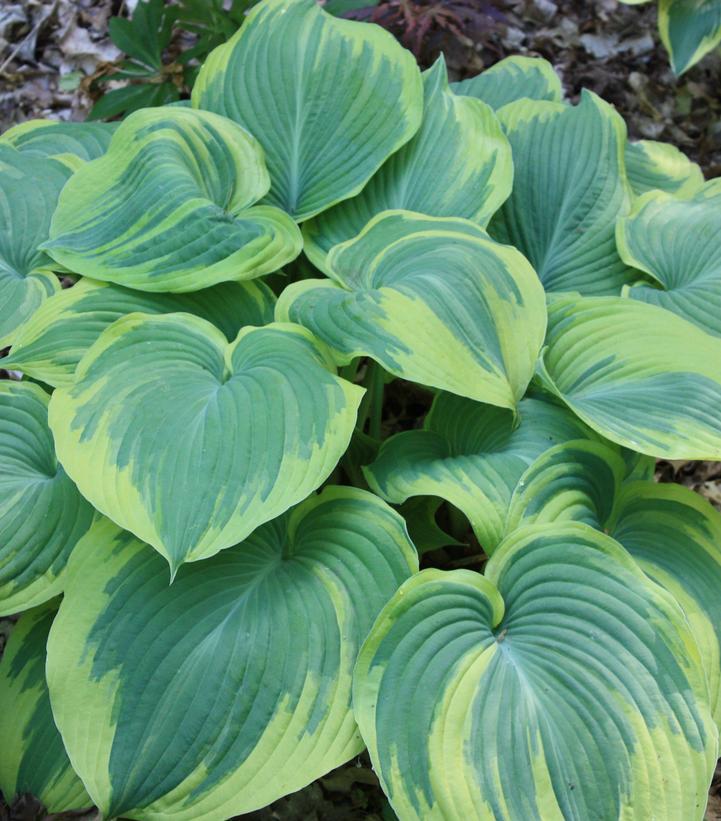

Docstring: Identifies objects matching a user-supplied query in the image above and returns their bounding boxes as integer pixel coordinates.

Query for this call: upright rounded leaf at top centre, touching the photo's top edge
[192,0,423,221]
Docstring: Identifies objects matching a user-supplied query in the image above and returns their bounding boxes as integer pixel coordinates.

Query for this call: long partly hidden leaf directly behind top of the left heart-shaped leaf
[3,279,275,386]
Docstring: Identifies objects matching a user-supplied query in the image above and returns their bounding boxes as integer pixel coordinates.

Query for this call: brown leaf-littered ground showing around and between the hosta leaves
[0,0,721,821]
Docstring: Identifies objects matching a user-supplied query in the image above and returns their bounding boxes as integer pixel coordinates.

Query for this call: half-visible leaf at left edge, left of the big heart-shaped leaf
[0,380,94,615]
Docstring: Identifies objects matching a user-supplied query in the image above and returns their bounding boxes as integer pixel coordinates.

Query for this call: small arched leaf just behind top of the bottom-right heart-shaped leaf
[506,440,626,533]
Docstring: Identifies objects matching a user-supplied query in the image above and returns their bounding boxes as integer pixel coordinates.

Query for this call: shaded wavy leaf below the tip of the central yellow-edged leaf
[365,393,595,552]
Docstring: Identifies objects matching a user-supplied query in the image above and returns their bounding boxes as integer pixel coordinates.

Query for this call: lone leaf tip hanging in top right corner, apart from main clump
[658,0,721,74]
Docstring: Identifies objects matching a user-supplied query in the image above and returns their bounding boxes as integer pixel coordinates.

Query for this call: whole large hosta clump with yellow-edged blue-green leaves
[0,0,721,821]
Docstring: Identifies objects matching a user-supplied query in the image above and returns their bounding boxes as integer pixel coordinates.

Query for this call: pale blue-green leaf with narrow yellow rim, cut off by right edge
[616,180,721,336]
